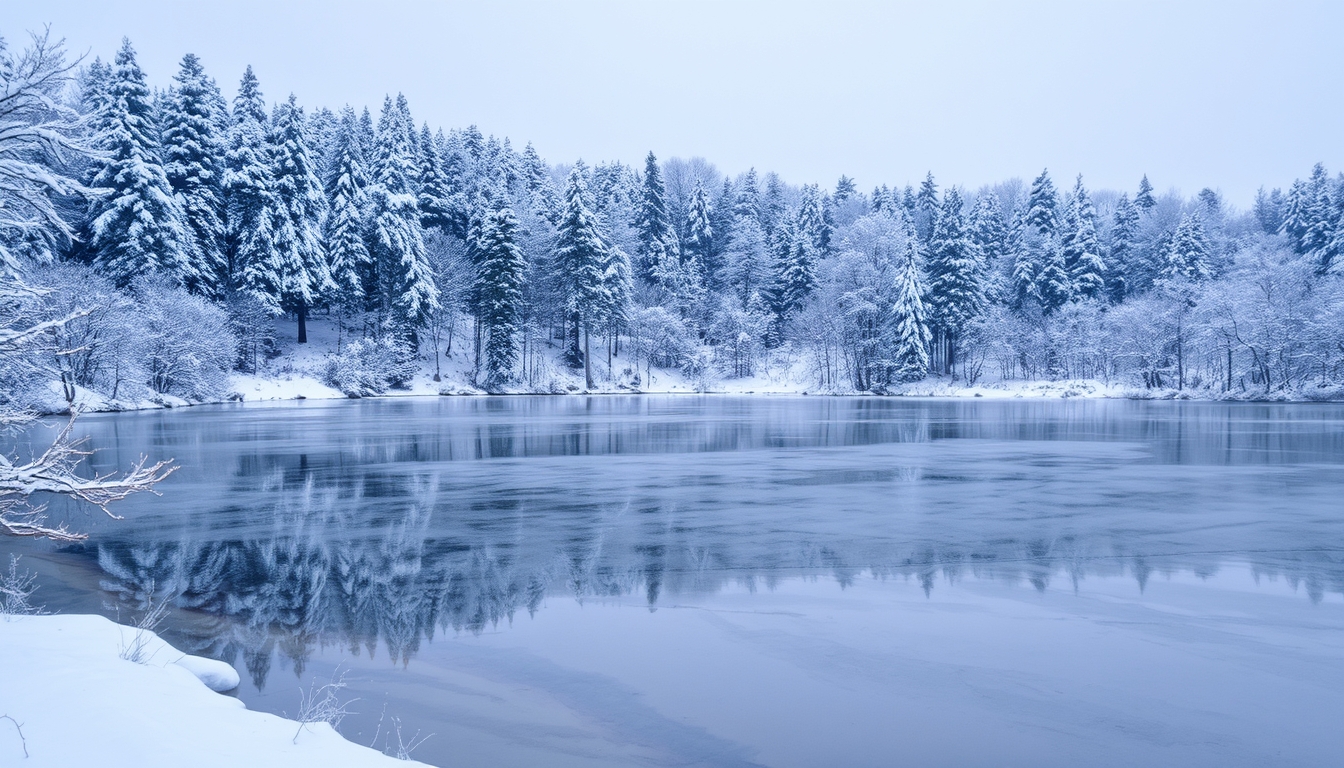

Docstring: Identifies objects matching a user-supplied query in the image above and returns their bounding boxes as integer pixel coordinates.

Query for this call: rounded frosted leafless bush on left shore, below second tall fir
[136,280,238,399]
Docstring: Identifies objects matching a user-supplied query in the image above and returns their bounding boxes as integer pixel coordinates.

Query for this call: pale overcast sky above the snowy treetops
[10,0,1344,207]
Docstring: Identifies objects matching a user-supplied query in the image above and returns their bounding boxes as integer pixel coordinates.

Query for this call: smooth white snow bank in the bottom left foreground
[0,616,421,768]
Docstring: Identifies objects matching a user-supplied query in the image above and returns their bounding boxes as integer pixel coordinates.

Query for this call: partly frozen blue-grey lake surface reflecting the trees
[0,395,1344,767]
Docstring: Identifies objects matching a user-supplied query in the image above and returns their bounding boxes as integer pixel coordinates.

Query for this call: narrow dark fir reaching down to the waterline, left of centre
[476,192,527,389]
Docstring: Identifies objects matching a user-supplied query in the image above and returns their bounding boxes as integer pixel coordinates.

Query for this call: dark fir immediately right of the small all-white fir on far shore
[927,187,985,374]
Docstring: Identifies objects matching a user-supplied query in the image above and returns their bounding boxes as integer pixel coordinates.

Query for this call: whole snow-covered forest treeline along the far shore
[0,34,1344,401]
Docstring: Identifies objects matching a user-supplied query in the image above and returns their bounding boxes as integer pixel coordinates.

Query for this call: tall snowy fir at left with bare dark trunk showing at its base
[271,94,336,344]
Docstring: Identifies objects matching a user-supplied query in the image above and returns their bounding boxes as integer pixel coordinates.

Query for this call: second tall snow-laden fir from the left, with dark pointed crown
[163,54,228,301]
